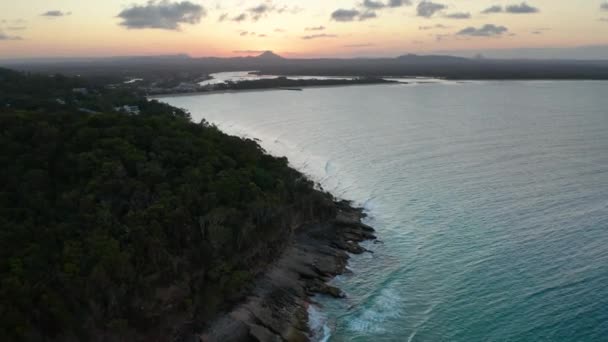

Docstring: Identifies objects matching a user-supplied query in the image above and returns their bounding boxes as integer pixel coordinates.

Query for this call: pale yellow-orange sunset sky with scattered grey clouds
[0,0,608,59]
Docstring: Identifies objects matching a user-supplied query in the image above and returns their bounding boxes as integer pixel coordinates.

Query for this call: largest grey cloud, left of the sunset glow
[118,0,207,31]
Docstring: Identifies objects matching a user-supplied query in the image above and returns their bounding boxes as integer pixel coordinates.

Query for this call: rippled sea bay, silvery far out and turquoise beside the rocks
[163,82,608,341]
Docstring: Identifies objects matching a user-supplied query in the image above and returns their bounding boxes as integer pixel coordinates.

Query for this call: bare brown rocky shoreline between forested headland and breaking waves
[200,201,376,342]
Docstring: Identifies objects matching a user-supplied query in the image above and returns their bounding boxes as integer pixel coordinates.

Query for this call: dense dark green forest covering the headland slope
[0,70,333,341]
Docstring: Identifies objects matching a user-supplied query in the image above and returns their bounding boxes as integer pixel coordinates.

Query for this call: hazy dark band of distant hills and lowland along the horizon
[0,51,608,80]
